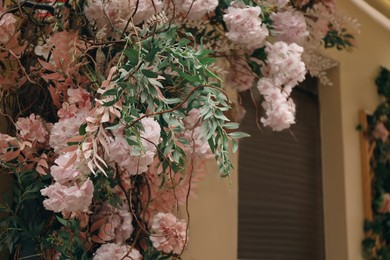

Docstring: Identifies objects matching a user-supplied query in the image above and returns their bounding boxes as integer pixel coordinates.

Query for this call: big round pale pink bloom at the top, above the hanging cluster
[223,6,269,50]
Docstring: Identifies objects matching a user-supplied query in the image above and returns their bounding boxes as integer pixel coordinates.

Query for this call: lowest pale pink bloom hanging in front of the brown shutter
[257,78,295,131]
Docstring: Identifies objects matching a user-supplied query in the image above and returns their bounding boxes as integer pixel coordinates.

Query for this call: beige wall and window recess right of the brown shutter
[320,1,390,260]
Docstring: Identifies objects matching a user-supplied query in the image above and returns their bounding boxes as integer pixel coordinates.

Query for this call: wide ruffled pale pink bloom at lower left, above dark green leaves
[41,179,94,212]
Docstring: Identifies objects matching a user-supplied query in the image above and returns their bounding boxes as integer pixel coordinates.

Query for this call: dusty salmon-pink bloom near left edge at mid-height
[16,114,49,143]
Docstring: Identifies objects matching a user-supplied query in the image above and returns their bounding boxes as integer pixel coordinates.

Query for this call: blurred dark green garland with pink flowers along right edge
[363,67,390,260]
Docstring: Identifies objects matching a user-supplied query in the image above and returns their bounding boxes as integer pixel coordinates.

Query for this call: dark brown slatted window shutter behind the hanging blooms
[238,80,325,260]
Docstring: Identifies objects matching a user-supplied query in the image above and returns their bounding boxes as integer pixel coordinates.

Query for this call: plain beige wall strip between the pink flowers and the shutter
[184,154,238,260]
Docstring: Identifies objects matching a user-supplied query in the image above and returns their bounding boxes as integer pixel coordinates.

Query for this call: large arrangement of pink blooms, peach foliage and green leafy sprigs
[0,0,356,259]
